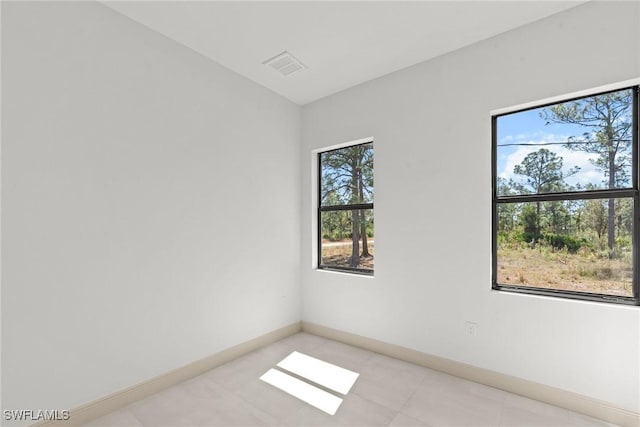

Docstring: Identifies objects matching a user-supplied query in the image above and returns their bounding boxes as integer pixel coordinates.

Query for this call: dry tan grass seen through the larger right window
[498,247,633,296]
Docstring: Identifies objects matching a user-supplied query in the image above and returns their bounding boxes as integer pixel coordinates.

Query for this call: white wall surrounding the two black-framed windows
[301,2,640,411]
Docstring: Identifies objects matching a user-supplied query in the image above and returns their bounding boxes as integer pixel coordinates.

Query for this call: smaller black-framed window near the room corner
[318,142,375,274]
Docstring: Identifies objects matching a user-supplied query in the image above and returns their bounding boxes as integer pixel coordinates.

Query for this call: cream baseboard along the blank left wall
[31,322,302,427]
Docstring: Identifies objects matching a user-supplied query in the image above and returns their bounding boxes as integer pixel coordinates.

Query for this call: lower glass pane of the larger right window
[497,198,634,297]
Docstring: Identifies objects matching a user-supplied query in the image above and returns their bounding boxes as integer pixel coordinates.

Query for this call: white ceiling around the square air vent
[103,0,584,105]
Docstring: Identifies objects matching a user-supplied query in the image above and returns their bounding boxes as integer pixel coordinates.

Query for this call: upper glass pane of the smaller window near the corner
[320,143,373,206]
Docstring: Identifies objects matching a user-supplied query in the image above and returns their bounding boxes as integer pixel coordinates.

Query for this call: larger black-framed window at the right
[492,86,640,305]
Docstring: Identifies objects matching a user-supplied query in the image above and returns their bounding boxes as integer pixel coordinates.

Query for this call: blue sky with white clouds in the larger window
[497,104,616,190]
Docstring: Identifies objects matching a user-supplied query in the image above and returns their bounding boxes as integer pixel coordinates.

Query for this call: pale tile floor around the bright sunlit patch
[84,333,612,427]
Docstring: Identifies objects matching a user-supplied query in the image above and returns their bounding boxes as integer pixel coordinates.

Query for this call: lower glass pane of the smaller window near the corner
[320,209,374,271]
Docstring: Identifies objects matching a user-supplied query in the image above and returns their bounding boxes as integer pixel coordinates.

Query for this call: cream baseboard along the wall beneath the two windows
[302,321,640,427]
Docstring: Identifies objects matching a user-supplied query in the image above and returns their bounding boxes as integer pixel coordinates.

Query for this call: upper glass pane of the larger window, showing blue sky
[496,89,633,196]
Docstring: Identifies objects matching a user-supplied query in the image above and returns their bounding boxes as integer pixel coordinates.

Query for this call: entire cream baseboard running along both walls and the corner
[32,321,640,427]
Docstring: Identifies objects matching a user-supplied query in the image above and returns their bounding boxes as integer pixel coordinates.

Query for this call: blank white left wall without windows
[2,2,301,422]
